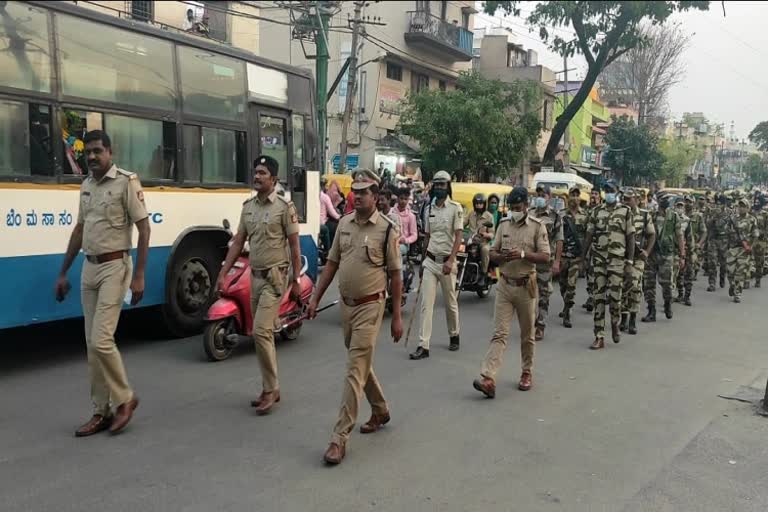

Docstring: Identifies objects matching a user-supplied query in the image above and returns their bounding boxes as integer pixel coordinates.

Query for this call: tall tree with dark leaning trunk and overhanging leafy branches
[485,1,709,165]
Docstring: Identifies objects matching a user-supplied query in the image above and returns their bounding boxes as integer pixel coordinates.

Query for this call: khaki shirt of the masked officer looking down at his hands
[492,215,551,279]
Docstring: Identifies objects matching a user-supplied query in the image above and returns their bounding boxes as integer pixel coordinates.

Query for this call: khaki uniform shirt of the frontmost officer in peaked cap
[328,211,402,300]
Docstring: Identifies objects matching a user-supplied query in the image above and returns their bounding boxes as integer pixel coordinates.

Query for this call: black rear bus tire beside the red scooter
[163,239,222,337]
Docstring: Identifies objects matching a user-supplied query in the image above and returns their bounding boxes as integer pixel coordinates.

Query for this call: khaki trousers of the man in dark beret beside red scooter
[251,267,286,393]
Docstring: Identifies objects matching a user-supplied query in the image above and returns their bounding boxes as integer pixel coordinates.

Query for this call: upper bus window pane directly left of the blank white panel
[179,46,245,121]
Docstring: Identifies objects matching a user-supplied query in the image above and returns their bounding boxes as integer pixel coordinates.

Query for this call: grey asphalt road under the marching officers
[0,279,768,512]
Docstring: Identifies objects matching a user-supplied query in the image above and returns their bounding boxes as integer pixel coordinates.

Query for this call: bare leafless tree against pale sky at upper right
[600,24,691,128]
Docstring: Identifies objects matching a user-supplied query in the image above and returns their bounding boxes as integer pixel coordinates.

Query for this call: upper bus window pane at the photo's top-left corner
[0,2,51,93]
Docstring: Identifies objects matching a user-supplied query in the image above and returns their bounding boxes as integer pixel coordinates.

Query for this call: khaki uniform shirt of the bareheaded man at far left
[77,164,147,256]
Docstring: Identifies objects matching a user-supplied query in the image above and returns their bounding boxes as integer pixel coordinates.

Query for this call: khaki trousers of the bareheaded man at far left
[80,254,133,416]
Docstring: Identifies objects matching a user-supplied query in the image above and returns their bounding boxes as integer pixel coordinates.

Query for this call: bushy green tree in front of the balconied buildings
[398,72,541,181]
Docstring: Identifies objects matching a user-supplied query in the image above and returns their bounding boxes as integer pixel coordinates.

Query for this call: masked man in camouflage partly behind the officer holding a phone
[531,185,563,341]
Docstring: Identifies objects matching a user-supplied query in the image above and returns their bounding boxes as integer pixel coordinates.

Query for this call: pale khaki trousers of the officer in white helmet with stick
[419,258,459,350]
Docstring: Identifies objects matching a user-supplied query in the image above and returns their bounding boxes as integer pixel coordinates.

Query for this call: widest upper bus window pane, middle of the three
[57,15,176,110]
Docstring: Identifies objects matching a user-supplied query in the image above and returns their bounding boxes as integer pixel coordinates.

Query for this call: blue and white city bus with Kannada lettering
[0,2,319,335]
